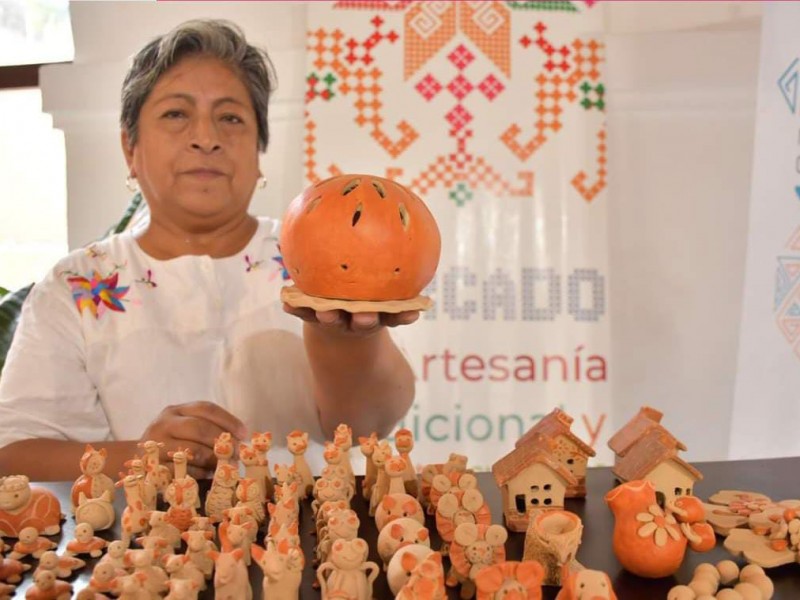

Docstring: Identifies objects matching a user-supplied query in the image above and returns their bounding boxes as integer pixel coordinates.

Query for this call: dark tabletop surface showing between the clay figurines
[6,458,800,600]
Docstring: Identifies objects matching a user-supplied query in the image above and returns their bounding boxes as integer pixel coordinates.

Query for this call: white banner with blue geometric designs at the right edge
[730,2,800,458]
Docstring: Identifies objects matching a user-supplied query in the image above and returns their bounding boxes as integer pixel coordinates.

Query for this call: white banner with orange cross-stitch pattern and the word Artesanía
[305,1,612,468]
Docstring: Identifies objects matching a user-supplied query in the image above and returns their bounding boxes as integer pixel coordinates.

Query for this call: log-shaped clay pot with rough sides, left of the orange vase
[523,510,583,585]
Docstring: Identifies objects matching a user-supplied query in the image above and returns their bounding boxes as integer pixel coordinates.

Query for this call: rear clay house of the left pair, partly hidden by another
[516,408,596,498]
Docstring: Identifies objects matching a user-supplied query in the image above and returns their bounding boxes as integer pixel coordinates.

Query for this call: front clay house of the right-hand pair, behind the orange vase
[612,427,703,506]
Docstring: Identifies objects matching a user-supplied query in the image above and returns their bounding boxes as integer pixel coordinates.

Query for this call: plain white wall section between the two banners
[607,12,760,460]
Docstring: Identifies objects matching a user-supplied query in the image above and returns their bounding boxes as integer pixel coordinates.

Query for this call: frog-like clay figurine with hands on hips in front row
[317,538,380,600]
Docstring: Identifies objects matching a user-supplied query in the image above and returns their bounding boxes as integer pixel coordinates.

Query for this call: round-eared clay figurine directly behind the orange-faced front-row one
[445,523,508,600]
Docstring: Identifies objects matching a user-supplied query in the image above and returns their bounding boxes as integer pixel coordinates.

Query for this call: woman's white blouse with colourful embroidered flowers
[0,218,322,468]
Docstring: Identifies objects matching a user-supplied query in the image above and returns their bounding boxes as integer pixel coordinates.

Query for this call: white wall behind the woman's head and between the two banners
[41,2,761,460]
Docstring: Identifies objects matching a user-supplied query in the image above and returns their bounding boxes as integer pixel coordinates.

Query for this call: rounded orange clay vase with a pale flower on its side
[605,480,686,578]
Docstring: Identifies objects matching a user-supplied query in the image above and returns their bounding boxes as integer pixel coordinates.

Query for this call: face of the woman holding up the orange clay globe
[122,56,259,230]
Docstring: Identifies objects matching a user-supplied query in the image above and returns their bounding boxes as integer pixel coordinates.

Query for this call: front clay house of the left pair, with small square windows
[492,433,578,531]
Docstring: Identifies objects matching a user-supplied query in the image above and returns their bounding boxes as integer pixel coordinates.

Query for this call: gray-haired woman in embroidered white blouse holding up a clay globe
[0,21,418,480]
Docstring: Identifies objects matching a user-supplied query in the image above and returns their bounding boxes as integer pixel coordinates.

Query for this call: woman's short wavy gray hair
[120,19,276,152]
